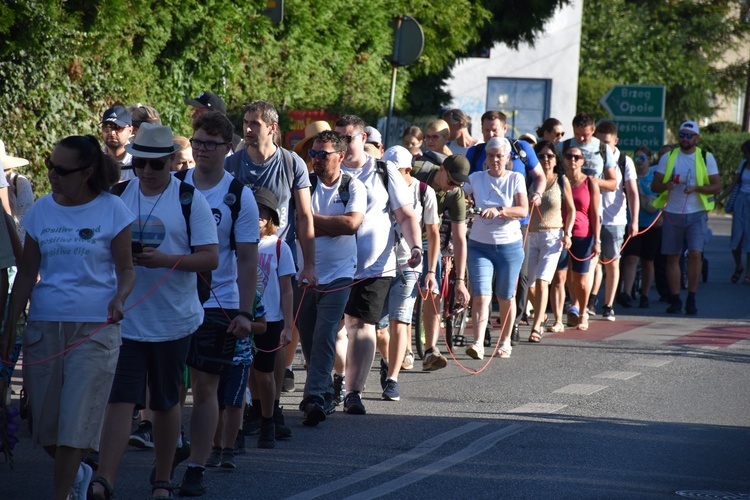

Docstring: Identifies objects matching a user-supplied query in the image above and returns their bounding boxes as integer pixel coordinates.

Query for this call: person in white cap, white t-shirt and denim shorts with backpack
[378,146,440,401]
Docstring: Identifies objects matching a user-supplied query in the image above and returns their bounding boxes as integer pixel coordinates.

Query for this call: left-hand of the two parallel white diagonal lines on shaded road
[289,422,488,500]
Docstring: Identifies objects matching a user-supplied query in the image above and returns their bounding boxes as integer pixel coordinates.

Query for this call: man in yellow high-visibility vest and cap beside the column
[651,121,721,314]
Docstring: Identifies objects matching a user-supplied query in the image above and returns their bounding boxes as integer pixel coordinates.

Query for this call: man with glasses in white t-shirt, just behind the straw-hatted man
[178,111,260,494]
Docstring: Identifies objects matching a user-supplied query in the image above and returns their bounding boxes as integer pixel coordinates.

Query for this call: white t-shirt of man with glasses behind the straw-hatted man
[185,169,260,309]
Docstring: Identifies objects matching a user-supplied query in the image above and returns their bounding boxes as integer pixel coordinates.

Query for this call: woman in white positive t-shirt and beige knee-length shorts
[1,135,135,500]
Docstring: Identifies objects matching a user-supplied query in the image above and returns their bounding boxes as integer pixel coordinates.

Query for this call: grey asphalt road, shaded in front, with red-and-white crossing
[0,216,750,500]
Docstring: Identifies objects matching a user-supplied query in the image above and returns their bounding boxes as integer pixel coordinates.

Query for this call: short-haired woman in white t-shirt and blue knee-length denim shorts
[464,137,529,359]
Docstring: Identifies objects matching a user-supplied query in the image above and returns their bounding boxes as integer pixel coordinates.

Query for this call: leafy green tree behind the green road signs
[578,0,750,134]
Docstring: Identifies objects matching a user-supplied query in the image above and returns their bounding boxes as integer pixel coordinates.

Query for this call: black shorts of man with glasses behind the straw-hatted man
[187,308,237,375]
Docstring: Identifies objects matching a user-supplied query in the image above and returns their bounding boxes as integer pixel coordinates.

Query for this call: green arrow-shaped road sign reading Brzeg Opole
[599,85,665,118]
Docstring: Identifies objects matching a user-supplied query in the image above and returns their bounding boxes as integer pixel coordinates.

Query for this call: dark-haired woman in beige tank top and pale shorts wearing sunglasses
[528,141,576,342]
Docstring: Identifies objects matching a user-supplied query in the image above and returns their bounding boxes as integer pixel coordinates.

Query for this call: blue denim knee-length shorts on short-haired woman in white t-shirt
[466,240,524,300]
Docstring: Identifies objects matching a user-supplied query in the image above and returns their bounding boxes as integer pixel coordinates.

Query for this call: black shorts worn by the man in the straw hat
[109,335,191,411]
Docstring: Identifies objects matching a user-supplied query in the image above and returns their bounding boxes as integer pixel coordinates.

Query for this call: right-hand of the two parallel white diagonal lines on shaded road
[347,424,529,500]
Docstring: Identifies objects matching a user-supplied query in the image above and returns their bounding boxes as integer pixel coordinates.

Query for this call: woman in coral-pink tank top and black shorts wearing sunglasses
[563,146,601,330]
